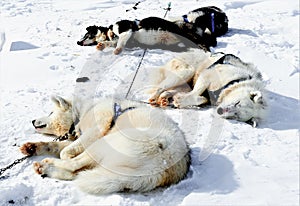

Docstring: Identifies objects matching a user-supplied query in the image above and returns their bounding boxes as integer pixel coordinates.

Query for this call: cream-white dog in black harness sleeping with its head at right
[149,51,267,126]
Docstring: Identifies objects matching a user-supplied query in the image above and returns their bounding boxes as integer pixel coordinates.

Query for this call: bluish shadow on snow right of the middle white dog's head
[259,91,300,130]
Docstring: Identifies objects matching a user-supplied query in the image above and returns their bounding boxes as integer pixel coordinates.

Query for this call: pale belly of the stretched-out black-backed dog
[134,29,179,45]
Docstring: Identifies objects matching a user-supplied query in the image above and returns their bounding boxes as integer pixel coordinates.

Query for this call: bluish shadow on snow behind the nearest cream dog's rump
[124,147,239,205]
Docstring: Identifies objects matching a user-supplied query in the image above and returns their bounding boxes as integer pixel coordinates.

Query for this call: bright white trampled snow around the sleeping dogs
[0,0,300,205]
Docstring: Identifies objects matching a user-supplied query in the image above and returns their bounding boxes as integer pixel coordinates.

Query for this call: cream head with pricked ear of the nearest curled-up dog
[32,96,73,136]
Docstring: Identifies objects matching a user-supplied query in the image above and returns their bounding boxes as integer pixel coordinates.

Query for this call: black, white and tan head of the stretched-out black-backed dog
[77,25,108,46]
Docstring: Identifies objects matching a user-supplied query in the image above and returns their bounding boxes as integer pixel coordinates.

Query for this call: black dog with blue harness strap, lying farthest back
[174,6,228,37]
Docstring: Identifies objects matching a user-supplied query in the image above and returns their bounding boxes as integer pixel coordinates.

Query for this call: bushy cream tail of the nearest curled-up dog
[74,167,157,195]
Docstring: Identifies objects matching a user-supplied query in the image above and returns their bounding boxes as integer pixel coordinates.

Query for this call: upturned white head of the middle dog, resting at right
[217,88,267,127]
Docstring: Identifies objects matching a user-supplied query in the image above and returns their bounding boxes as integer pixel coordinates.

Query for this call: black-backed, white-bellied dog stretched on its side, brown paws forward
[77,17,217,54]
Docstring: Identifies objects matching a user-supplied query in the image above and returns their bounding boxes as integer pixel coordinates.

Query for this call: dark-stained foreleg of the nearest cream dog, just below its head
[20,141,72,157]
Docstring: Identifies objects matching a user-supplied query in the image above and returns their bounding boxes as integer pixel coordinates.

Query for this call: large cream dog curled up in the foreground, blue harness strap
[20,96,190,195]
